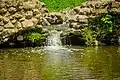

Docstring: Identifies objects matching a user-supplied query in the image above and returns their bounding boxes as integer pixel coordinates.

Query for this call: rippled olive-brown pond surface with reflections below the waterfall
[0,46,120,80]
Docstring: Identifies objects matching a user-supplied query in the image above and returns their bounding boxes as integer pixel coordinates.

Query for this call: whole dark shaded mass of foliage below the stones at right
[86,13,120,44]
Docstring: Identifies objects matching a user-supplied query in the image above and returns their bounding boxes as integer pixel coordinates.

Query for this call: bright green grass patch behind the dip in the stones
[40,0,85,11]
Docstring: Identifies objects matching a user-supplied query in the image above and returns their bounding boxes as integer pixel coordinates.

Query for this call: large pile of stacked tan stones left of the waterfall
[0,0,48,42]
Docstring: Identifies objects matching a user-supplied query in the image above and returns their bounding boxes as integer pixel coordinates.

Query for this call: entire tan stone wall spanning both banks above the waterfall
[0,0,120,43]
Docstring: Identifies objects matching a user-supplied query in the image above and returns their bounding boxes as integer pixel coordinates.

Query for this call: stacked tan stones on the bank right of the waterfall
[63,0,120,29]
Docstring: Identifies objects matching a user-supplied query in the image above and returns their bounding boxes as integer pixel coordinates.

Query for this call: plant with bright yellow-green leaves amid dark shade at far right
[100,13,118,40]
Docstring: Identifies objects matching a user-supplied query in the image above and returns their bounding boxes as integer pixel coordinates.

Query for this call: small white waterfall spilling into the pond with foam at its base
[44,30,71,53]
